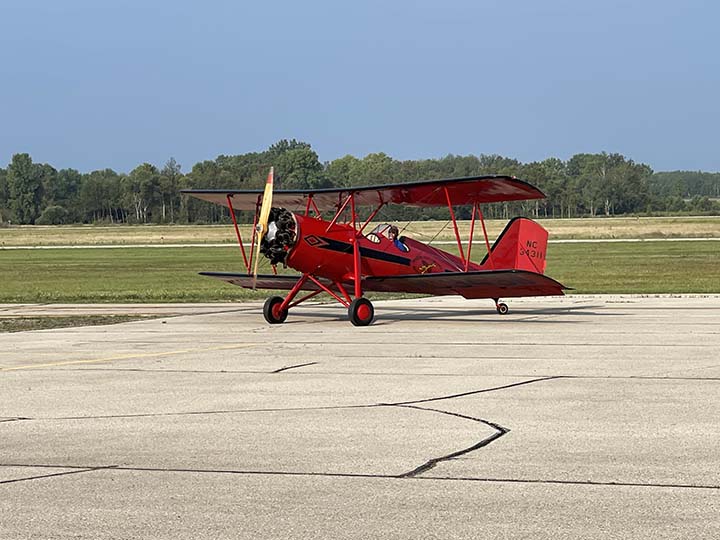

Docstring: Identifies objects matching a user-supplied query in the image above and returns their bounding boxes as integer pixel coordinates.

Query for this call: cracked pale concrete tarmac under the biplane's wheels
[0,295,720,540]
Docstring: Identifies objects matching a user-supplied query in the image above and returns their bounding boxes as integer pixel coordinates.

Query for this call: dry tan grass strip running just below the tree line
[0,216,720,247]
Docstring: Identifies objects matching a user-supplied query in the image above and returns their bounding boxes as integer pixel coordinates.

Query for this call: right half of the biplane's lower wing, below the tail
[363,270,567,298]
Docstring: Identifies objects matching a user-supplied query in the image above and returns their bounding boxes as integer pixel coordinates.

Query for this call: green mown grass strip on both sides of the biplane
[0,241,720,303]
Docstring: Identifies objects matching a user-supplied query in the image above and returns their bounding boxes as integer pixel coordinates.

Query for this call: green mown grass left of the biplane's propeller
[0,248,267,303]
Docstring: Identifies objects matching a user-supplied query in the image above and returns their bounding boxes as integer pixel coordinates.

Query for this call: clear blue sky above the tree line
[0,0,720,172]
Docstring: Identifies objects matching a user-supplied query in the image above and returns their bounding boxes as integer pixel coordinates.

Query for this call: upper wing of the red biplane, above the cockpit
[182,176,545,211]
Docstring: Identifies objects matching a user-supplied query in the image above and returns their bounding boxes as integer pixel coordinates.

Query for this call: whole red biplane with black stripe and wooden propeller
[183,169,566,326]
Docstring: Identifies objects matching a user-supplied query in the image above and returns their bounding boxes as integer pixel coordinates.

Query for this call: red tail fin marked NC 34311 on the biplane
[481,218,548,274]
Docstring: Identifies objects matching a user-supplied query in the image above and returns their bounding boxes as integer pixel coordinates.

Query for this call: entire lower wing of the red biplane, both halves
[201,270,568,298]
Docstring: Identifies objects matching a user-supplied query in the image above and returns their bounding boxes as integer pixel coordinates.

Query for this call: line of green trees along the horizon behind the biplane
[0,140,720,225]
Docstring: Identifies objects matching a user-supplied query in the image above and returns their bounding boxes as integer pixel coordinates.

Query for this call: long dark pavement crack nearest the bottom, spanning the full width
[0,463,720,491]
